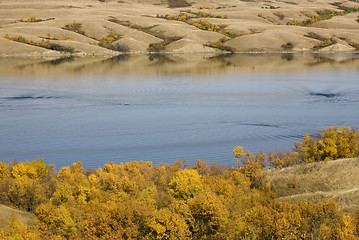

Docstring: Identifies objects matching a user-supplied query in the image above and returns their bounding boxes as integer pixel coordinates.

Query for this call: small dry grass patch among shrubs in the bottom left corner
[0,204,35,228]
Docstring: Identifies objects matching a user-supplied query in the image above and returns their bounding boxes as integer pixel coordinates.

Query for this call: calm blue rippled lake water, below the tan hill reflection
[0,54,359,168]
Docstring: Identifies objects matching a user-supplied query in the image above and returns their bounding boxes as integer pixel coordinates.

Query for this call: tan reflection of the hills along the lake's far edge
[0,53,359,75]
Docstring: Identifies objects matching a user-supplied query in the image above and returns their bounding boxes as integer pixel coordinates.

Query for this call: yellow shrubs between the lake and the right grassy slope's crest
[233,125,359,168]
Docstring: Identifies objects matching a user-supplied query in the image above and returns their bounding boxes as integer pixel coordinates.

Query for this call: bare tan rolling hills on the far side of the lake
[0,0,359,57]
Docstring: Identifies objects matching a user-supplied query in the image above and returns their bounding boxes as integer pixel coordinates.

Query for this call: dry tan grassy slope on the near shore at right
[265,158,359,212]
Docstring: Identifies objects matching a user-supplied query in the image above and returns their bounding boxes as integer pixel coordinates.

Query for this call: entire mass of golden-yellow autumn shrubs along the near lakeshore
[0,127,359,240]
